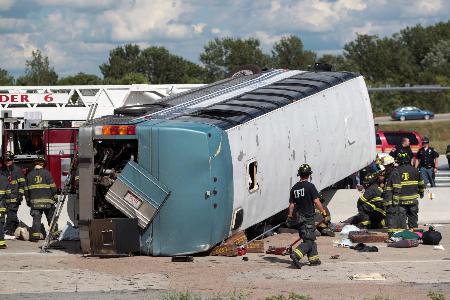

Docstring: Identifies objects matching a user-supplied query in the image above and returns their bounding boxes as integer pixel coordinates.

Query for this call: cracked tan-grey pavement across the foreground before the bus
[0,224,450,300]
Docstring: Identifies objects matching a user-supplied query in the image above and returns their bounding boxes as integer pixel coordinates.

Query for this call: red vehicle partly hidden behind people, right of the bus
[376,130,422,154]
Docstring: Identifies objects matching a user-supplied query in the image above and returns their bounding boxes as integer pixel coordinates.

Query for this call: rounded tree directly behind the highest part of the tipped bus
[272,35,317,70]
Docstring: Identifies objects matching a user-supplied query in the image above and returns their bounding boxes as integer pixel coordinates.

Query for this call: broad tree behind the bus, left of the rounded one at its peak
[200,38,270,82]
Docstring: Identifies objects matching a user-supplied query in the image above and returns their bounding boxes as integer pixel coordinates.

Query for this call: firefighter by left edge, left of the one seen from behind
[3,151,26,239]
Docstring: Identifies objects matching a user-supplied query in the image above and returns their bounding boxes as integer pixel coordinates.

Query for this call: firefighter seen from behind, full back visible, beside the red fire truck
[26,157,58,242]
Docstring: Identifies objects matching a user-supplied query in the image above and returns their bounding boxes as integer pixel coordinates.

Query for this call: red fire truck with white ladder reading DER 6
[0,84,199,189]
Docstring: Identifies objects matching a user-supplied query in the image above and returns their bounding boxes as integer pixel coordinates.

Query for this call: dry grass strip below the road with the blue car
[380,120,450,154]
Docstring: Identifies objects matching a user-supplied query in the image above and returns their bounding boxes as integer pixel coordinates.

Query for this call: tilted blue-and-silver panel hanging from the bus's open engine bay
[106,161,170,229]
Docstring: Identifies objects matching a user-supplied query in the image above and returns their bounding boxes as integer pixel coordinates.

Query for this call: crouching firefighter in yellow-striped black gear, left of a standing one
[351,171,386,229]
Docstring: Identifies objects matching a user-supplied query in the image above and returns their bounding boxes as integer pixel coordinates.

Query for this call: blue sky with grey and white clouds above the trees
[0,0,450,76]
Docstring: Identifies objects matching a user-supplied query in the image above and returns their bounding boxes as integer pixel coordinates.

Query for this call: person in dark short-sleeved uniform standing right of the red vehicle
[416,137,439,187]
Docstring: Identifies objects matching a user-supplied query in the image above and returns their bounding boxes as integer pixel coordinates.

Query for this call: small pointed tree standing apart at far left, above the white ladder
[17,50,58,85]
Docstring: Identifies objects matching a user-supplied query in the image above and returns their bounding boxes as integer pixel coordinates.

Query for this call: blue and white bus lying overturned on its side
[79,70,376,256]
